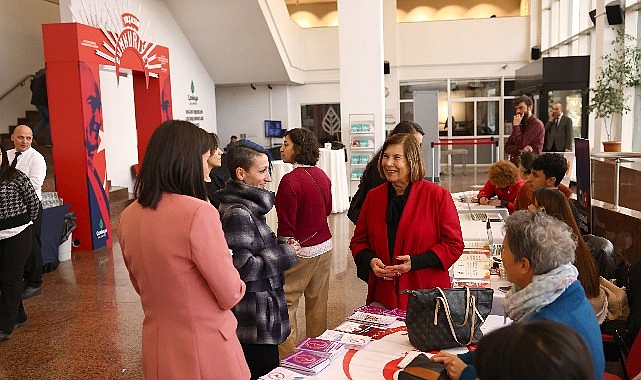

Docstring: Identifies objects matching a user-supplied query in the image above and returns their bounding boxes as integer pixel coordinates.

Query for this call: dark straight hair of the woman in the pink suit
[134,120,211,209]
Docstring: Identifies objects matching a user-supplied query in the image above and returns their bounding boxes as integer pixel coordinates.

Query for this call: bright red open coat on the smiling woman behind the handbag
[350,180,463,309]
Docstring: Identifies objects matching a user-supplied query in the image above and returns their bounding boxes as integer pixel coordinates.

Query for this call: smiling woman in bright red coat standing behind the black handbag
[350,133,463,309]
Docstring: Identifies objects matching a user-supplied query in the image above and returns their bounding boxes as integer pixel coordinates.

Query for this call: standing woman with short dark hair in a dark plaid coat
[216,140,301,379]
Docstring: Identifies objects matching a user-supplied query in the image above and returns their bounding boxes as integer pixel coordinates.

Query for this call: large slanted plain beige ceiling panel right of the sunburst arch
[164,0,291,86]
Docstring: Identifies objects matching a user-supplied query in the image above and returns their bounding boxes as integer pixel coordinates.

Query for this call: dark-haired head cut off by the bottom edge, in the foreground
[474,321,595,380]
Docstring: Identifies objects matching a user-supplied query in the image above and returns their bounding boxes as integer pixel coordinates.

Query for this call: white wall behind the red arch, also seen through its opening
[60,0,216,191]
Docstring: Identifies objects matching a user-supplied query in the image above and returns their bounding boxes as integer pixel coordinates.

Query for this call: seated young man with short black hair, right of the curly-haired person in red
[514,153,574,212]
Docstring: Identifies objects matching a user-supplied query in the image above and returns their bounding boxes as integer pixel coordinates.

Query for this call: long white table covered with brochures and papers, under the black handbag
[261,193,510,380]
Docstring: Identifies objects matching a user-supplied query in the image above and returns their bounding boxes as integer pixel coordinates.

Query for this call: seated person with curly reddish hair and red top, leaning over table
[476,160,524,214]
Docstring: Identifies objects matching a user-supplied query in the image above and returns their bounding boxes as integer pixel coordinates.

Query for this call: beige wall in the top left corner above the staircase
[0,0,60,133]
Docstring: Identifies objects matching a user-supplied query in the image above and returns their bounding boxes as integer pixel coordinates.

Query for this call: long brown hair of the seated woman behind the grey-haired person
[532,187,600,298]
